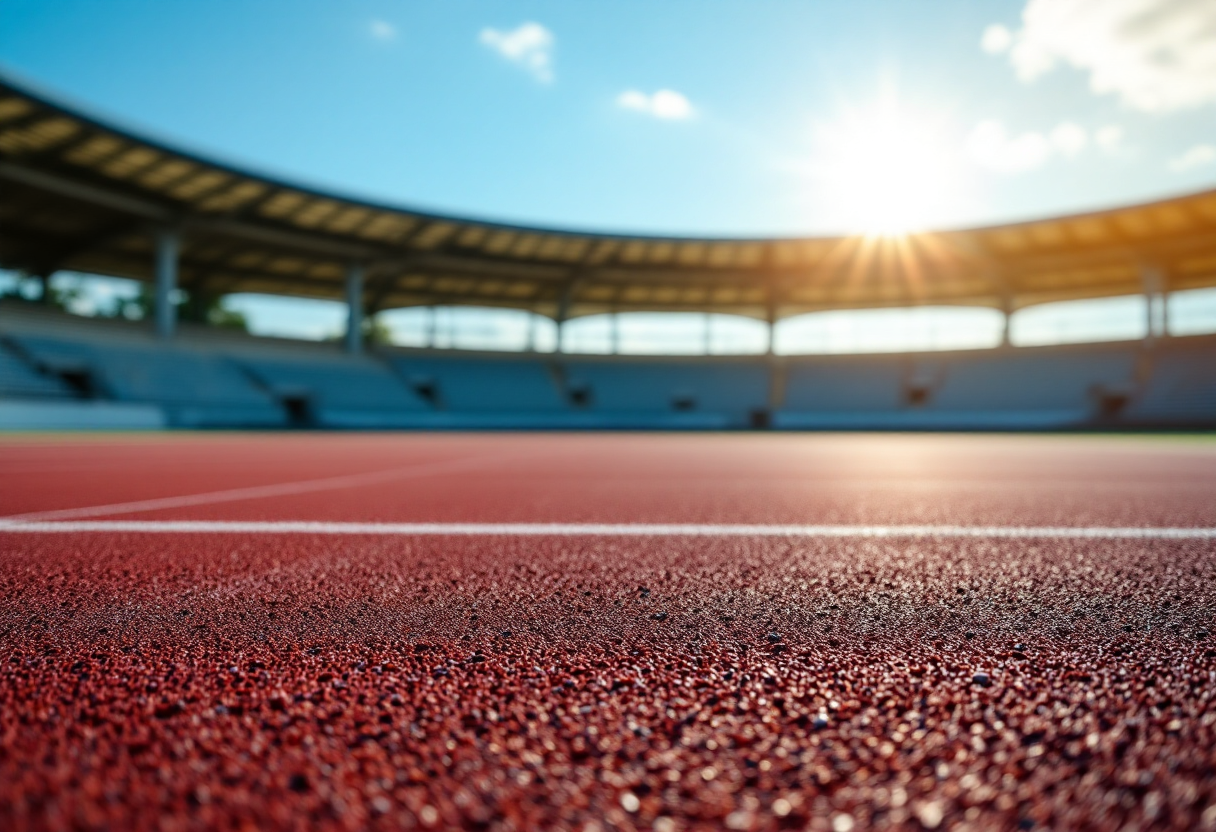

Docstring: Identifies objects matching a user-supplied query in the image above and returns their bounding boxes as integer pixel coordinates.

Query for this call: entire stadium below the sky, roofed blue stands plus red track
[0,3,1216,832]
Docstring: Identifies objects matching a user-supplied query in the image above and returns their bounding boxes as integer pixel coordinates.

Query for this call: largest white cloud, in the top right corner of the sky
[981,0,1216,112]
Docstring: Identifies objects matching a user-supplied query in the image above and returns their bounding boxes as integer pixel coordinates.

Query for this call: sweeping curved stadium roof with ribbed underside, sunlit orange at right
[0,71,1216,320]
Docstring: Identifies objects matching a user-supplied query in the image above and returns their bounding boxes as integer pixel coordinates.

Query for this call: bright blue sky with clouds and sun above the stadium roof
[0,0,1216,235]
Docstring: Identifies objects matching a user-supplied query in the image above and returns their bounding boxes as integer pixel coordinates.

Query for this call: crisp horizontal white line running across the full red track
[0,518,1216,540]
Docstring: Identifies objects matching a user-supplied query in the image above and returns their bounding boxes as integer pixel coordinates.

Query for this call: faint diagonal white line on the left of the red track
[0,454,518,525]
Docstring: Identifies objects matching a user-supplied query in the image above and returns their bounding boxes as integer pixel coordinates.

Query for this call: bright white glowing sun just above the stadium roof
[812,101,959,236]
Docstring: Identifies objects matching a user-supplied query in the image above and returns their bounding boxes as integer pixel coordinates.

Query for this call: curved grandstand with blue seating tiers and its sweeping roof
[0,72,1216,429]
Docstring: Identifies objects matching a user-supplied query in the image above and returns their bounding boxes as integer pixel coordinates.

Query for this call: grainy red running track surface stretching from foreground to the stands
[0,435,1216,832]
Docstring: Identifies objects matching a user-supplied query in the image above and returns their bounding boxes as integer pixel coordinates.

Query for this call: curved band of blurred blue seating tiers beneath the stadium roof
[0,304,1216,429]
